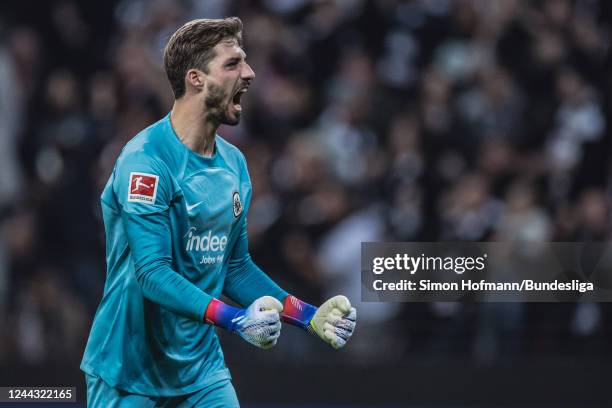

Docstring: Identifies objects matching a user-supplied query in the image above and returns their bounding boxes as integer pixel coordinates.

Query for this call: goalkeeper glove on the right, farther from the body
[281,295,357,349]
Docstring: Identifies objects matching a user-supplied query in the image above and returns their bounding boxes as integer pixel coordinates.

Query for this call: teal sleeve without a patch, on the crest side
[223,216,288,306]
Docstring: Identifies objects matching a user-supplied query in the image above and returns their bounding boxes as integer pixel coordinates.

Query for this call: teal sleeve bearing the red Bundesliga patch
[113,150,212,321]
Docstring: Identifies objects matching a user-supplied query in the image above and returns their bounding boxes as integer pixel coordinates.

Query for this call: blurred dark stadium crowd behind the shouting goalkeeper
[0,0,612,408]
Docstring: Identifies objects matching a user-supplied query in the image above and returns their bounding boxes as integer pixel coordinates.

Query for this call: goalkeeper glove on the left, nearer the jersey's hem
[206,296,283,349]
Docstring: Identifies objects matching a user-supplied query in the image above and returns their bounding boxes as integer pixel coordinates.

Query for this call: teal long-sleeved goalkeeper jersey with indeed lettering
[81,115,287,396]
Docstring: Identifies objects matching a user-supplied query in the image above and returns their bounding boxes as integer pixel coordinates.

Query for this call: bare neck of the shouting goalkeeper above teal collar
[170,99,219,157]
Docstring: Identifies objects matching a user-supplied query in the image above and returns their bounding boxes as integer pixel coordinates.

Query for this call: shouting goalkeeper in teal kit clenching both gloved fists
[81,17,356,408]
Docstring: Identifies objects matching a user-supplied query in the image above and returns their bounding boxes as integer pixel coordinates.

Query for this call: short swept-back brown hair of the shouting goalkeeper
[164,17,242,99]
